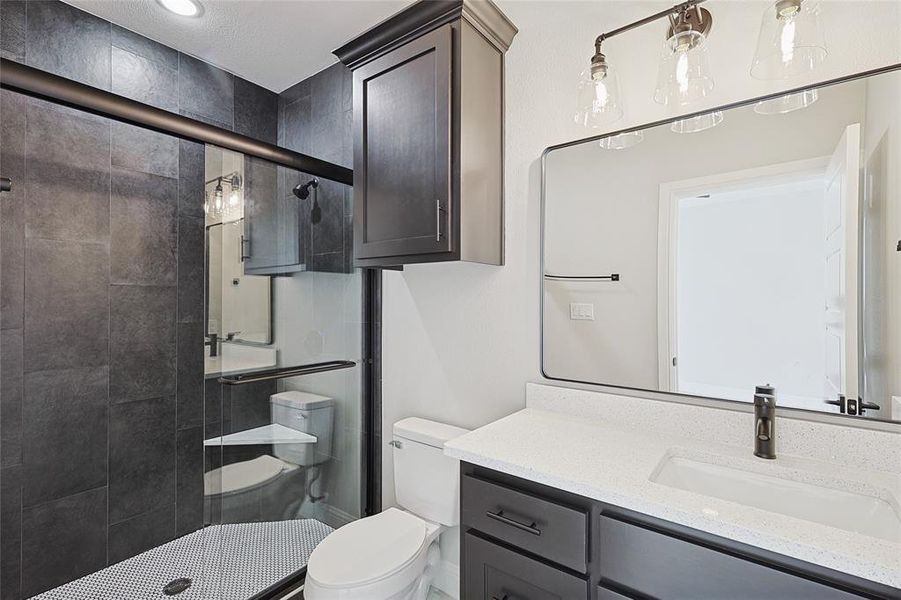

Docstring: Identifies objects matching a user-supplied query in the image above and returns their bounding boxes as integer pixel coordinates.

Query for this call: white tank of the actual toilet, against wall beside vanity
[392,417,467,527]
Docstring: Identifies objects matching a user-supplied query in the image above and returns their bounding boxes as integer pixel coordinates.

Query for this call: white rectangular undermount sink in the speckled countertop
[650,454,901,543]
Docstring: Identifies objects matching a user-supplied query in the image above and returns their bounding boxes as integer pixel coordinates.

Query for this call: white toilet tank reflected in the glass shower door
[269,390,335,467]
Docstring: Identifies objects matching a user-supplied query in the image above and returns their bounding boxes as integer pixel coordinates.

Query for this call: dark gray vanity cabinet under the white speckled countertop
[460,463,901,600]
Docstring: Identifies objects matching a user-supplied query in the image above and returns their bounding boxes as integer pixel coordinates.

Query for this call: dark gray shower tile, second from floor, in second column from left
[22,367,109,506]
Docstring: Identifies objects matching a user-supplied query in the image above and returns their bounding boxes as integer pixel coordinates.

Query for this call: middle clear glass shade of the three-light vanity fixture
[654,30,713,107]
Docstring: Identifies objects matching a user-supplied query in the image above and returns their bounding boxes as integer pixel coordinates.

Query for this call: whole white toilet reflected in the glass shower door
[204,390,334,522]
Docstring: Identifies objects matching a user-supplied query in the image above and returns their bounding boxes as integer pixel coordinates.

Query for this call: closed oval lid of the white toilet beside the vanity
[307,508,426,587]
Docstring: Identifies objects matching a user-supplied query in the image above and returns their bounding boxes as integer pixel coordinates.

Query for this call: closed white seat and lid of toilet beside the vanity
[307,508,438,599]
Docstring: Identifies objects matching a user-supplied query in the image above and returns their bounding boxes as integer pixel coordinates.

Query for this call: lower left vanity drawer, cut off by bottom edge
[463,533,588,600]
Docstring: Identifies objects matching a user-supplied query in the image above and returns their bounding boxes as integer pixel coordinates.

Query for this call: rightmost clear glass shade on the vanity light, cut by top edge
[751,0,827,79]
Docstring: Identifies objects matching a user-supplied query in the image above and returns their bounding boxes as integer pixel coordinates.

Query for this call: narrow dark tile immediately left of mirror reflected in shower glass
[178,215,205,323]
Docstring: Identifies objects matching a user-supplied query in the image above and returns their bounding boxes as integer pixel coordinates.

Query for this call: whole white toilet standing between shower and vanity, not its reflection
[304,417,467,600]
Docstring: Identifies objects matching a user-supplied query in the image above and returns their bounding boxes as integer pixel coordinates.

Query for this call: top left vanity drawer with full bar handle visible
[462,475,588,573]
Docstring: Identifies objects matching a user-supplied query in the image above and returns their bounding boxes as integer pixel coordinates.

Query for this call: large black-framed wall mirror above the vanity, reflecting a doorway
[542,66,901,421]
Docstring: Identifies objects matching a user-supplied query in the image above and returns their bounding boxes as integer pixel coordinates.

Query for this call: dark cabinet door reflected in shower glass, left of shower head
[242,156,303,275]
